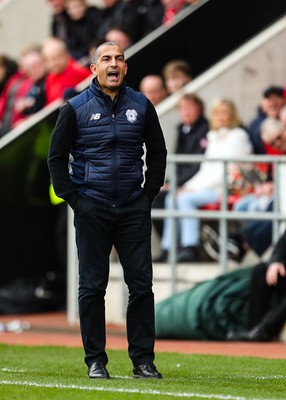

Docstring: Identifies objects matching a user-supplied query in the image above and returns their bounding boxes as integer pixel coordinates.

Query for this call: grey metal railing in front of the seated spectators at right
[152,154,286,293]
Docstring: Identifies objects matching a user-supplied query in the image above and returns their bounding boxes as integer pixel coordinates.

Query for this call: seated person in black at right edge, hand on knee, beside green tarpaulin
[227,232,286,342]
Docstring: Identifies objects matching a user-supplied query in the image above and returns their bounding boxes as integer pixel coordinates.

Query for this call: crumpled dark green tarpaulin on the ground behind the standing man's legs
[155,267,252,340]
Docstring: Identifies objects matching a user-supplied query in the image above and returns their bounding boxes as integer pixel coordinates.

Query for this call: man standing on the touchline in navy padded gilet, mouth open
[48,42,167,379]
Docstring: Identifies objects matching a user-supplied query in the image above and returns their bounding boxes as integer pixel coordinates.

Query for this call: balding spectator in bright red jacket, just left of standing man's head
[42,37,91,104]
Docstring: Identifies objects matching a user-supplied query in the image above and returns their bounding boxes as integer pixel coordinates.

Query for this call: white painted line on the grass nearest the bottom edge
[0,380,274,400]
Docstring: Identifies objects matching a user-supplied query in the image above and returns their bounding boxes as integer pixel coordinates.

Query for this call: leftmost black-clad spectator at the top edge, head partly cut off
[47,0,70,43]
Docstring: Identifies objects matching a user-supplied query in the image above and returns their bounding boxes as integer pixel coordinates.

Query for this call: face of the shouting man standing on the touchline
[90,45,127,97]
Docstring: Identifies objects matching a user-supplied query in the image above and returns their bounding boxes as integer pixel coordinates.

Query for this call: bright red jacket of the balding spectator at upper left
[46,59,91,104]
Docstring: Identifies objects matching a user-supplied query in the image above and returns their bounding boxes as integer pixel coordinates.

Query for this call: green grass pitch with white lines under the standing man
[0,345,286,400]
